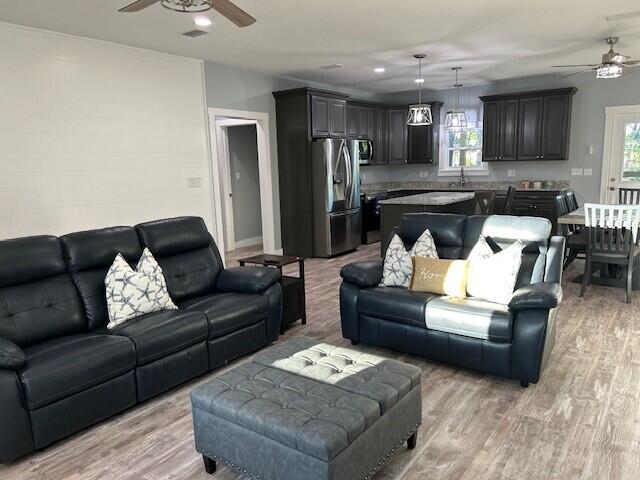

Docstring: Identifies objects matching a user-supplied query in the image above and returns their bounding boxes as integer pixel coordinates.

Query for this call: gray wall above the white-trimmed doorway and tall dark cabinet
[205,62,372,248]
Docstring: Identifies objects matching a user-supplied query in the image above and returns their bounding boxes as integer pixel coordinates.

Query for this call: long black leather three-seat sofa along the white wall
[0,217,282,463]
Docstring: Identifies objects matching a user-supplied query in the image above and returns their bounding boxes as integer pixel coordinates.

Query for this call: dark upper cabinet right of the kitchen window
[480,88,577,162]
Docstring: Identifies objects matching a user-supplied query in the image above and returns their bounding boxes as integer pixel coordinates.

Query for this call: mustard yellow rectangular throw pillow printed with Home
[409,257,469,298]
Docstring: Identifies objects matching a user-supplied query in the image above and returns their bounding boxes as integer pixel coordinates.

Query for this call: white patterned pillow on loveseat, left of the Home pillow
[380,229,438,288]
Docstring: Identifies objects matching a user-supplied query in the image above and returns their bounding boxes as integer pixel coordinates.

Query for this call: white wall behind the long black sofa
[0,24,212,238]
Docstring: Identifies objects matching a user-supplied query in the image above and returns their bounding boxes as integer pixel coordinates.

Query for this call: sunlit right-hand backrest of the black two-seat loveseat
[461,215,551,288]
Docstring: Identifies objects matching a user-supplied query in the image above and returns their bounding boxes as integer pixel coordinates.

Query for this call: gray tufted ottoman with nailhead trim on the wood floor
[191,337,422,480]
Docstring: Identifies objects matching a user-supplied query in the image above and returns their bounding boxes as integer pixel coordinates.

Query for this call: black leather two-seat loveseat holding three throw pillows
[340,213,565,387]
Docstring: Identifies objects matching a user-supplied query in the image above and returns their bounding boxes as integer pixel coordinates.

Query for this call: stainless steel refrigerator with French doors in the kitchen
[311,138,360,257]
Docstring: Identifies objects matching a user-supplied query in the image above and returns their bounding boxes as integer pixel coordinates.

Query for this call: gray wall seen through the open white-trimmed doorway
[227,125,262,242]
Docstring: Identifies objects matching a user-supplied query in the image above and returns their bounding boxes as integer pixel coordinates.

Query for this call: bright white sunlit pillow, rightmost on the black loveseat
[467,235,523,305]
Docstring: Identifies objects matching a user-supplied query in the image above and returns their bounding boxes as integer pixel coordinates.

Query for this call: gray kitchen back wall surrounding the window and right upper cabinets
[362,69,640,201]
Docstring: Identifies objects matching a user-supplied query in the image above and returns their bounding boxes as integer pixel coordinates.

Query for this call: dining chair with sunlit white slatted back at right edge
[580,203,640,303]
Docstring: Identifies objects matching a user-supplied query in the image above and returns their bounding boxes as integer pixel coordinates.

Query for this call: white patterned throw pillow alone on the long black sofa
[104,248,178,329]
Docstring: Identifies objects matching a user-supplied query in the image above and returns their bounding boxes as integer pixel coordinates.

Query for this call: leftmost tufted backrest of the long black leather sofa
[0,236,87,347]
